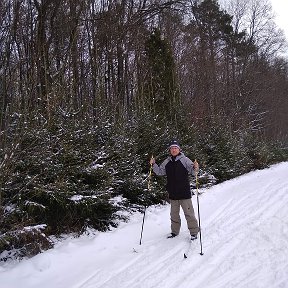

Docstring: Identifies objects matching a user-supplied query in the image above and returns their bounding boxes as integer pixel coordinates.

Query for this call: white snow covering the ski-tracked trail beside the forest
[0,162,288,288]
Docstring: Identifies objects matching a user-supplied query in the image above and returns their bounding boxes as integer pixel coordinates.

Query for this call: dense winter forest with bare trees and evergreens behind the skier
[0,0,288,261]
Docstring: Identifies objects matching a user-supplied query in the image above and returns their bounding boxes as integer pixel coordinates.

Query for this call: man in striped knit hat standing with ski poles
[150,140,199,240]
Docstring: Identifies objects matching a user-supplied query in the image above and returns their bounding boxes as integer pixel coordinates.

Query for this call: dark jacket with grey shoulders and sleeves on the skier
[153,153,195,200]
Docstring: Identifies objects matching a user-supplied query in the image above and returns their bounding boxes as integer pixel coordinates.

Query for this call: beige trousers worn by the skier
[170,199,199,235]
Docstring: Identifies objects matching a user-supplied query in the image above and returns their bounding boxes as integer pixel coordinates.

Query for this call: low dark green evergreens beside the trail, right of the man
[192,122,287,182]
